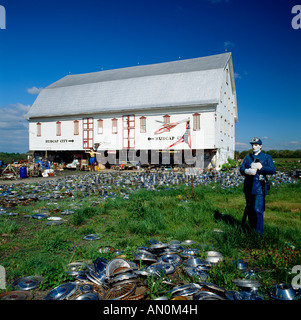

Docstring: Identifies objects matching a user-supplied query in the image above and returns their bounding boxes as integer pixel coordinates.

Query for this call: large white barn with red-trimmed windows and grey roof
[27,53,238,168]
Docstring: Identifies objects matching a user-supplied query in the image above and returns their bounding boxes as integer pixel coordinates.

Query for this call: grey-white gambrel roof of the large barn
[27,53,235,119]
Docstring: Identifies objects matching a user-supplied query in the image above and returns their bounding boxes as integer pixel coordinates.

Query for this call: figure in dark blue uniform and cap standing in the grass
[240,137,276,236]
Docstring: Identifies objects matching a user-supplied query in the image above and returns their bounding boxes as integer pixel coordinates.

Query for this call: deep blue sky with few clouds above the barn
[0,0,301,152]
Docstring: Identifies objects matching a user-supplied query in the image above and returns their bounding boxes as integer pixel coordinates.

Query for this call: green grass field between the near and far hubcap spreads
[0,176,301,298]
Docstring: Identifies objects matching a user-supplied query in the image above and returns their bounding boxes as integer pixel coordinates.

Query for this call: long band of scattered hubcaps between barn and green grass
[0,170,296,207]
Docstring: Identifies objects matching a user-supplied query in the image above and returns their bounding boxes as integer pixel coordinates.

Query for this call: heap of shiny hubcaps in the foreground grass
[0,239,301,300]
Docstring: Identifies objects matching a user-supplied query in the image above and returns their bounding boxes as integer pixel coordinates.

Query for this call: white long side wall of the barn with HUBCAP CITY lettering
[29,106,216,151]
